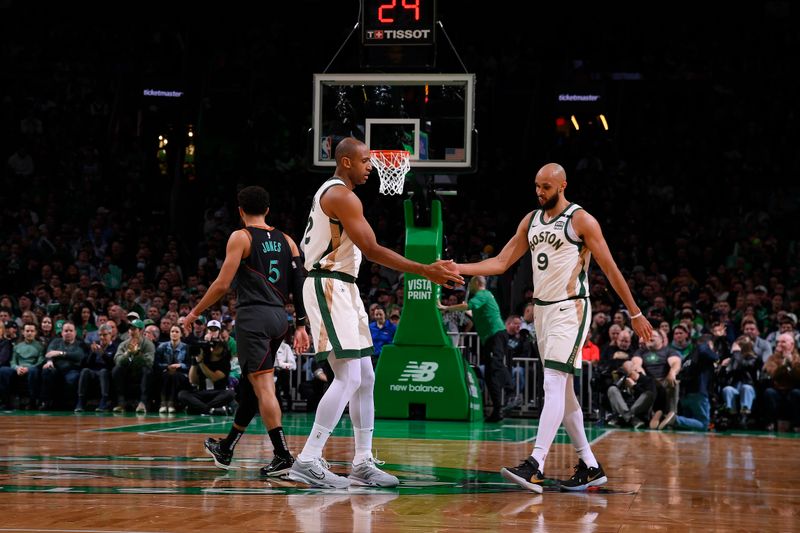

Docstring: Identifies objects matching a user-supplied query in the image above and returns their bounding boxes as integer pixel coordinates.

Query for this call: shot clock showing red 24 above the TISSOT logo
[361,0,436,45]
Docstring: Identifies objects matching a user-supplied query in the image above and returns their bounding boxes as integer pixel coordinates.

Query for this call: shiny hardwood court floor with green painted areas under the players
[0,411,800,533]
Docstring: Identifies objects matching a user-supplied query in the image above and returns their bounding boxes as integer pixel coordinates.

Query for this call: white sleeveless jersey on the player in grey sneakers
[300,177,361,278]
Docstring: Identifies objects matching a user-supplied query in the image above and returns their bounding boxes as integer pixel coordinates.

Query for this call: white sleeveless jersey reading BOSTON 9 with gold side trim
[528,204,592,305]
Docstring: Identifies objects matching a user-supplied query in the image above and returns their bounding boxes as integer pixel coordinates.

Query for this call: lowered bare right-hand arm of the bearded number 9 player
[572,210,653,342]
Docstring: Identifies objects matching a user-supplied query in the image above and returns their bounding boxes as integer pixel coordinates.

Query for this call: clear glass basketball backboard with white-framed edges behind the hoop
[311,74,476,172]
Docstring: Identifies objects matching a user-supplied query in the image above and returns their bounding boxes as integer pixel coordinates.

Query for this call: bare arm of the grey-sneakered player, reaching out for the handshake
[320,187,464,285]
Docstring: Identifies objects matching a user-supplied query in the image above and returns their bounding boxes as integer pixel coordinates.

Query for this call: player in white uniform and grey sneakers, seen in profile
[289,137,464,488]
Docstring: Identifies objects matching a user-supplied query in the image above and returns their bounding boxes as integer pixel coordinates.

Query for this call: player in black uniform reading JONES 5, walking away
[184,186,309,477]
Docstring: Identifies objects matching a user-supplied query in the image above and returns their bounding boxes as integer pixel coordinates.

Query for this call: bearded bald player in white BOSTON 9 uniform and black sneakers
[458,163,652,492]
